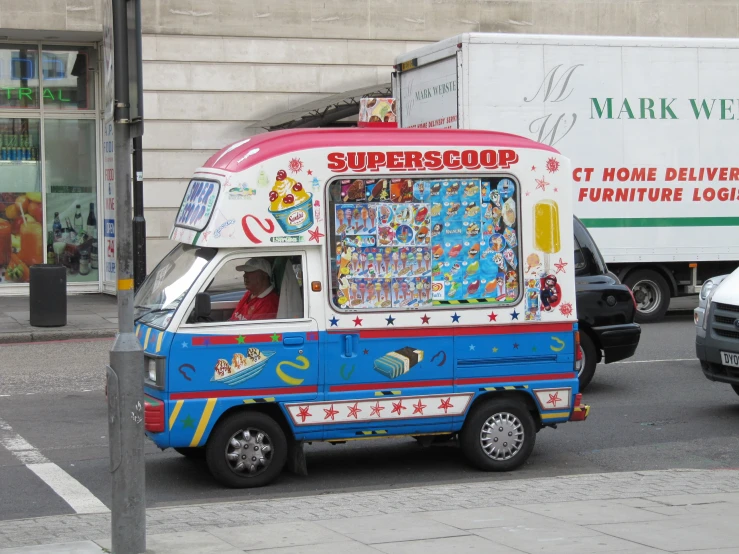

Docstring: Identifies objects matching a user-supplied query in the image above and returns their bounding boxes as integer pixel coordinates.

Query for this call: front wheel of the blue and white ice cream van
[210,412,287,488]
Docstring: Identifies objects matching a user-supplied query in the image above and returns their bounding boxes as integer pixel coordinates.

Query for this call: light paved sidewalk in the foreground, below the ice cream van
[0,470,739,554]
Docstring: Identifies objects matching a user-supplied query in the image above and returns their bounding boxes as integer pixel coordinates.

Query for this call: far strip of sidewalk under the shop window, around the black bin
[0,294,118,343]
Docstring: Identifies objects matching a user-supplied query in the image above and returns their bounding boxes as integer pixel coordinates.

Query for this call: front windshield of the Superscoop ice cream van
[134,244,217,329]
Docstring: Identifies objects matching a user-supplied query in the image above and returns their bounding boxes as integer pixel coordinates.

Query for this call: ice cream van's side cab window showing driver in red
[190,256,304,323]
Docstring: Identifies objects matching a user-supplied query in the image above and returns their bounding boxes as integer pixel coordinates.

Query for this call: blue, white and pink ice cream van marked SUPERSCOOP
[135,129,589,487]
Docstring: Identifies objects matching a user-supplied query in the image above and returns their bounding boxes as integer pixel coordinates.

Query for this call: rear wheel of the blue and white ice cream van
[460,398,536,471]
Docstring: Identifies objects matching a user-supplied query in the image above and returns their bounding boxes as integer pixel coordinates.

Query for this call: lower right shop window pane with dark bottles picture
[44,119,99,282]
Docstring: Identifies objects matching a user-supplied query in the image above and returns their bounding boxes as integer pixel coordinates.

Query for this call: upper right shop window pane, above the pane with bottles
[41,45,96,110]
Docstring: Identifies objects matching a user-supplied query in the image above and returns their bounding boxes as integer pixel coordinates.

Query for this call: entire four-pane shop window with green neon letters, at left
[0,43,99,290]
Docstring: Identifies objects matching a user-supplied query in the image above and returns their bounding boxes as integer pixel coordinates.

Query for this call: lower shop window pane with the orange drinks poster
[0,118,45,283]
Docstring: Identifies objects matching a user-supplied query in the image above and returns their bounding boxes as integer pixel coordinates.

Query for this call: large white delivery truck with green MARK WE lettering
[393,33,739,322]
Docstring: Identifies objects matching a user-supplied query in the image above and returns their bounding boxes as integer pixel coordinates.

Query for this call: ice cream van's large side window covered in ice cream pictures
[328,176,521,310]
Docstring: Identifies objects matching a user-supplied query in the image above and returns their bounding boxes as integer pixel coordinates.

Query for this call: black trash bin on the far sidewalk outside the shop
[29,265,67,327]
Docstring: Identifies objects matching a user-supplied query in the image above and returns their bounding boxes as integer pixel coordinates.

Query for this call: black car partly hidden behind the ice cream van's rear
[574,217,641,391]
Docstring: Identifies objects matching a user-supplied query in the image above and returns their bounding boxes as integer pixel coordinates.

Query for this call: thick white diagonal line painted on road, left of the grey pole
[0,419,110,514]
